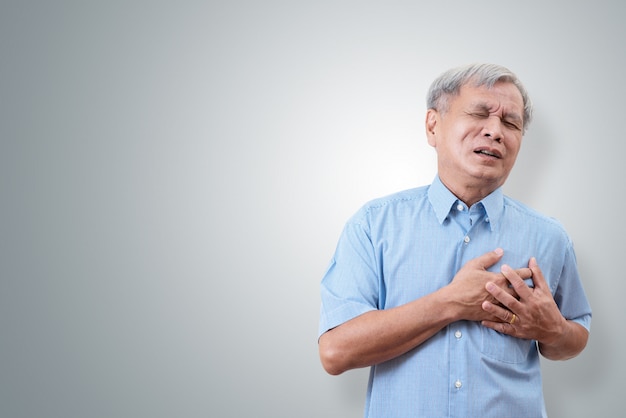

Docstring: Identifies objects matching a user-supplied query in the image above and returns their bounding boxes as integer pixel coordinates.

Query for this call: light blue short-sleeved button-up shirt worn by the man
[319,177,591,418]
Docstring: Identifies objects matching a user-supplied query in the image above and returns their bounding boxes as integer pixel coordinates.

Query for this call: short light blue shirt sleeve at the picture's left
[318,212,380,337]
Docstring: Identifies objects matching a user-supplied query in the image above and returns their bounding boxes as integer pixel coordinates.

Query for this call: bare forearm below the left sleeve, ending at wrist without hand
[319,289,459,375]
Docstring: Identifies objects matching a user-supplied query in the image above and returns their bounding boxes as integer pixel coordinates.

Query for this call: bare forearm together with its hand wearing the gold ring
[483,257,589,360]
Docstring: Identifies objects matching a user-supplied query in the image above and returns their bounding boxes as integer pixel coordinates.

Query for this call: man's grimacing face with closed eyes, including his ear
[426,82,524,198]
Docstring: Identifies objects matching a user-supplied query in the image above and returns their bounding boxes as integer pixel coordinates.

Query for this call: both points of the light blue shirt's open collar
[428,175,504,231]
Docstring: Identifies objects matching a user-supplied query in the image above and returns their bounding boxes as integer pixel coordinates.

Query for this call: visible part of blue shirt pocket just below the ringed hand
[481,327,535,363]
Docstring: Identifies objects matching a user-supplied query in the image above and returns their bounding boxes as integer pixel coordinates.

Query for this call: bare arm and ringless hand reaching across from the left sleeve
[319,249,530,375]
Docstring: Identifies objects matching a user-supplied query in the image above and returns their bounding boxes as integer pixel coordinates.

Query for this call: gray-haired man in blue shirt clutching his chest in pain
[319,64,591,418]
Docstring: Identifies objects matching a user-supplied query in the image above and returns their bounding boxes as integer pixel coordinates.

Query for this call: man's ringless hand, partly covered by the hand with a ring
[449,248,532,321]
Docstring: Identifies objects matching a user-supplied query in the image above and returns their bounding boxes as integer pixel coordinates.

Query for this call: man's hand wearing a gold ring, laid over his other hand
[482,257,567,344]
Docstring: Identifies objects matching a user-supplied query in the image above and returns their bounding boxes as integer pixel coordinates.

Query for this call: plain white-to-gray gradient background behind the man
[0,0,626,418]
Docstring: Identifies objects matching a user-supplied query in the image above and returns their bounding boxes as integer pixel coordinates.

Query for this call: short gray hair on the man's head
[426,64,533,132]
